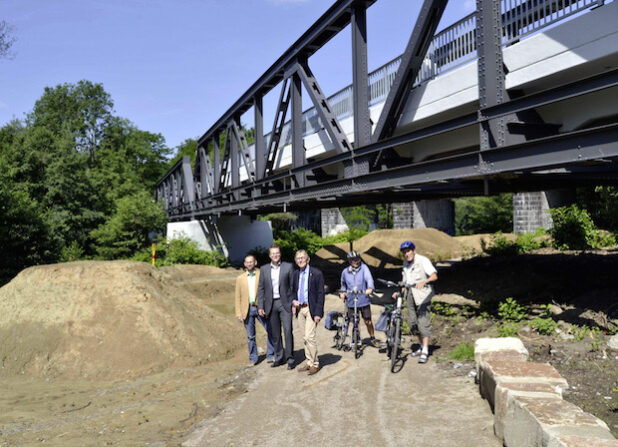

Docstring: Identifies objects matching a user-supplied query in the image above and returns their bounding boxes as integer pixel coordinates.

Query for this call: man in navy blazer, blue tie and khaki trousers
[292,250,324,375]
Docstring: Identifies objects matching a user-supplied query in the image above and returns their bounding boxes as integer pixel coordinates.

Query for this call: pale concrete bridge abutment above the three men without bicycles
[167,216,273,264]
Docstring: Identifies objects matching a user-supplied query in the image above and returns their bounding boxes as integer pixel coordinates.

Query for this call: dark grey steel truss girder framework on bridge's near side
[157,0,618,220]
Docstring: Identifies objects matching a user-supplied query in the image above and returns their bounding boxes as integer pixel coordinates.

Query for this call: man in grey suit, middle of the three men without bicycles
[258,245,295,369]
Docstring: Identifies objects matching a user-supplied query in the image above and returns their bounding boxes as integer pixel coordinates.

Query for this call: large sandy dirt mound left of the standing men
[0,261,243,378]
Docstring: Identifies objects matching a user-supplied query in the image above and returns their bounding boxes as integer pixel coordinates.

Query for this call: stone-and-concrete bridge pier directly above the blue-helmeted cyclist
[393,200,455,235]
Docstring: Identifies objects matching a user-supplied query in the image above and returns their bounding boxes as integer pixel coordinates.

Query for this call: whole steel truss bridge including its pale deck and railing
[157,0,618,221]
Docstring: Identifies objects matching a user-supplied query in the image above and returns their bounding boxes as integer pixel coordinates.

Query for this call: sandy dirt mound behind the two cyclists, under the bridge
[316,228,464,269]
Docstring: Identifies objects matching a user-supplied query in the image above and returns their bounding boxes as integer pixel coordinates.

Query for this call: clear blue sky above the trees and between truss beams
[0,0,475,147]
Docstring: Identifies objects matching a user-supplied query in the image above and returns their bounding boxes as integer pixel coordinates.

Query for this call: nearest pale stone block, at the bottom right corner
[504,395,613,447]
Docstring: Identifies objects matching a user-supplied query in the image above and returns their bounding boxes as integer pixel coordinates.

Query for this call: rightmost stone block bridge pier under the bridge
[513,189,575,233]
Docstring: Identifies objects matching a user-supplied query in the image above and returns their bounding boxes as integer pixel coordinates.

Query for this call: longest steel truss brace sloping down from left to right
[295,62,351,154]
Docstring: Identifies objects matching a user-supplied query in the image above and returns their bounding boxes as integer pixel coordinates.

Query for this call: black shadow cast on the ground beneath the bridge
[312,247,618,326]
